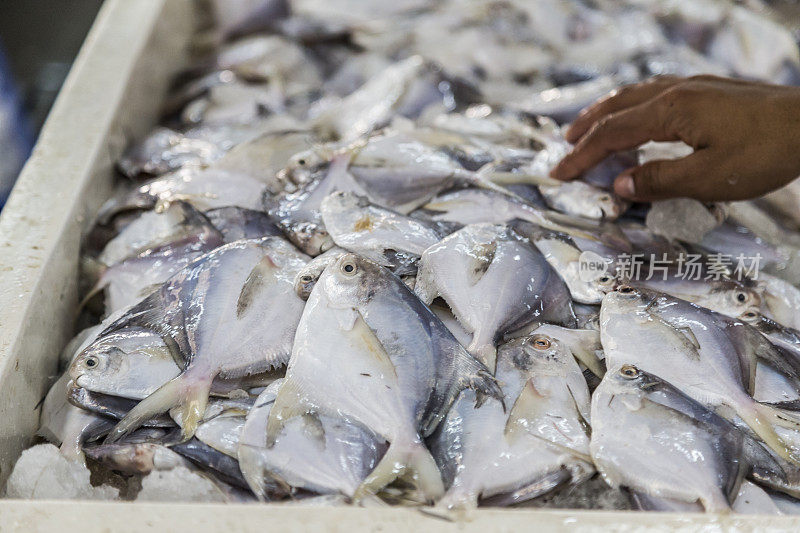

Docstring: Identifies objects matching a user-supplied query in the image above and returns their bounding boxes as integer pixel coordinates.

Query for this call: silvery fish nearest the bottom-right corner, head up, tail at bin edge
[590,364,747,513]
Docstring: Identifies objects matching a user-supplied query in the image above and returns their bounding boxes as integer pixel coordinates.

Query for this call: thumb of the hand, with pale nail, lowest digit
[614,150,728,202]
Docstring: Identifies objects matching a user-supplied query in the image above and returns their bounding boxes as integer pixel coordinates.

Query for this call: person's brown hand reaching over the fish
[551,76,800,201]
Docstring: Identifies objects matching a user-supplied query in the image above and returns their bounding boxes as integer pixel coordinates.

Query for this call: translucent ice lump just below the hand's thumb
[645,198,722,243]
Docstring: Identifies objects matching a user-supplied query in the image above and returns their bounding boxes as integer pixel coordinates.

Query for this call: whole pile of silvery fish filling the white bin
[12,0,800,513]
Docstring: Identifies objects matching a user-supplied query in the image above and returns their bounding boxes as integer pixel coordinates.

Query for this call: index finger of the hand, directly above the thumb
[550,99,680,180]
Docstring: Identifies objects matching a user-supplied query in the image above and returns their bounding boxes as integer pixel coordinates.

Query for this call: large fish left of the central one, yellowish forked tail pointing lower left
[100,237,308,442]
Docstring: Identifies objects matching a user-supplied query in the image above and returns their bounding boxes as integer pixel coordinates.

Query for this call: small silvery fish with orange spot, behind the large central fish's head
[320,191,447,273]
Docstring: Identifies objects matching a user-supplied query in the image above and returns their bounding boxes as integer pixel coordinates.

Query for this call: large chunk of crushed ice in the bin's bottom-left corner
[6,444,119,500]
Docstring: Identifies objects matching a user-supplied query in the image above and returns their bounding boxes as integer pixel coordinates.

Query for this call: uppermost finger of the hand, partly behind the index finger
[565,76,683,144]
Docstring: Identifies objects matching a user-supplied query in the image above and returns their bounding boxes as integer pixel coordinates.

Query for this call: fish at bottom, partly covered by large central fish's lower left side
[237,382,387,500]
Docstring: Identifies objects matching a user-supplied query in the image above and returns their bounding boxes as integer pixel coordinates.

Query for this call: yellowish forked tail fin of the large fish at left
[105,372,211,444]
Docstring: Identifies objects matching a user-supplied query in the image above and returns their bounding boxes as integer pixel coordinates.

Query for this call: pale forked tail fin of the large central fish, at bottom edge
[353,440,444,501]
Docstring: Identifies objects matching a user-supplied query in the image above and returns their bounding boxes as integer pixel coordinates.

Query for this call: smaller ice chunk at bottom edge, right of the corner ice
[136,466,229,503]
